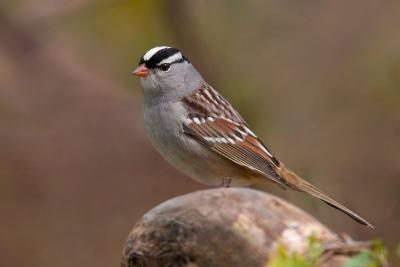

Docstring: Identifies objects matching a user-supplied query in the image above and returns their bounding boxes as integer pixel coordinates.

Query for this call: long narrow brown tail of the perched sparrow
[277,164,374,228]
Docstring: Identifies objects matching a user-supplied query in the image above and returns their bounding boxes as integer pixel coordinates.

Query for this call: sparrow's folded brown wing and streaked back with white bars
[183,84,285,186]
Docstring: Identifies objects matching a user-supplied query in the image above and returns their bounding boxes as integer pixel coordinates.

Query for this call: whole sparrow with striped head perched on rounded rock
[132,46,374,228]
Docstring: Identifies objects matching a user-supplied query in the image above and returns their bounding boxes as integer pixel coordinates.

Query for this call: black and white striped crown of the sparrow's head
[139,46,188,69]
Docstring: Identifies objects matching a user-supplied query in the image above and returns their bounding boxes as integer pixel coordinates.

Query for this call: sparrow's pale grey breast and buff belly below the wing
[145,102,250,186]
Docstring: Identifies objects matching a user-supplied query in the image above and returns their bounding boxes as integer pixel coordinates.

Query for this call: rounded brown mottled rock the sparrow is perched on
[121,188,347,267]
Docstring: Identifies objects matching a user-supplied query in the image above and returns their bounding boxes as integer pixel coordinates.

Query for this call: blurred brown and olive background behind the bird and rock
[0,0,400,267]
